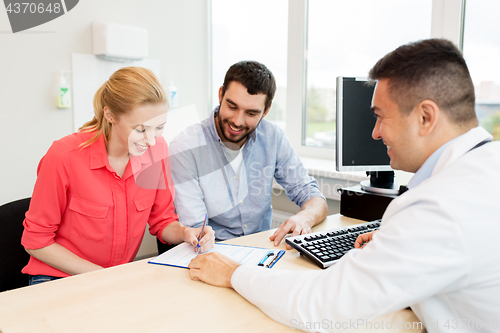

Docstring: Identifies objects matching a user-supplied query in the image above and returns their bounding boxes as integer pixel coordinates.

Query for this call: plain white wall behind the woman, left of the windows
[0,0,208,204]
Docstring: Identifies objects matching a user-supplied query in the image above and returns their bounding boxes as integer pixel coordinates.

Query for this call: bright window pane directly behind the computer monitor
[303,0,432,148]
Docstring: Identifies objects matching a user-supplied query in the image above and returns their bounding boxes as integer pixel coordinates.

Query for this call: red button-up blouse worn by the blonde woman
[21,133,178,277]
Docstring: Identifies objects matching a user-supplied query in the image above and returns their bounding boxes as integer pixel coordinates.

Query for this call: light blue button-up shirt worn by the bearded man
[170,107,324,240]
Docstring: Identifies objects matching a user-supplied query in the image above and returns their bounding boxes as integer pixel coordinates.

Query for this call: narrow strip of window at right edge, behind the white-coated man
[463,0,500,140]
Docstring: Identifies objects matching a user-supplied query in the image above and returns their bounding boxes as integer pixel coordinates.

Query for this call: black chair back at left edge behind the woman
[0,198,31,292]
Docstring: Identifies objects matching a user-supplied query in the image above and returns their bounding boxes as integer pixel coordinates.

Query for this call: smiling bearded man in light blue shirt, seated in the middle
[170,61,327,246]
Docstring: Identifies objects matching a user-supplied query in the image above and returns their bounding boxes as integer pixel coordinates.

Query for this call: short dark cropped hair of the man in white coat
[369,39,477,125]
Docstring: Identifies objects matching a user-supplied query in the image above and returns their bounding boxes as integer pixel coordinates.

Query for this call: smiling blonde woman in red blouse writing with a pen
[21,67,214,284]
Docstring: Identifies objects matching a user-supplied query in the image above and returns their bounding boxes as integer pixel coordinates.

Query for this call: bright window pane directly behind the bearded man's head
[212,0,288,129]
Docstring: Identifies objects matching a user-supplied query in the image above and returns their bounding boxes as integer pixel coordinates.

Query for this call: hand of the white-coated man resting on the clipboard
[188,252,240,288]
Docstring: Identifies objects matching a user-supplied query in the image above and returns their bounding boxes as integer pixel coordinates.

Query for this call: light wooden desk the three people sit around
[0,215,420,333]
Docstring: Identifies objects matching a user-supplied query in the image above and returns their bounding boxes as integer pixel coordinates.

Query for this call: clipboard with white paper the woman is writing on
[148,243,285,268]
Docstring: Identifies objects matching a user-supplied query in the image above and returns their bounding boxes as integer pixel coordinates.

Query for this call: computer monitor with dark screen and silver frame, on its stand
[336,76,399,194]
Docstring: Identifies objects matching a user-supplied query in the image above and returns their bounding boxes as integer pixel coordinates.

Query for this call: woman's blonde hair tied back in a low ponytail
[79,67,168,148]
